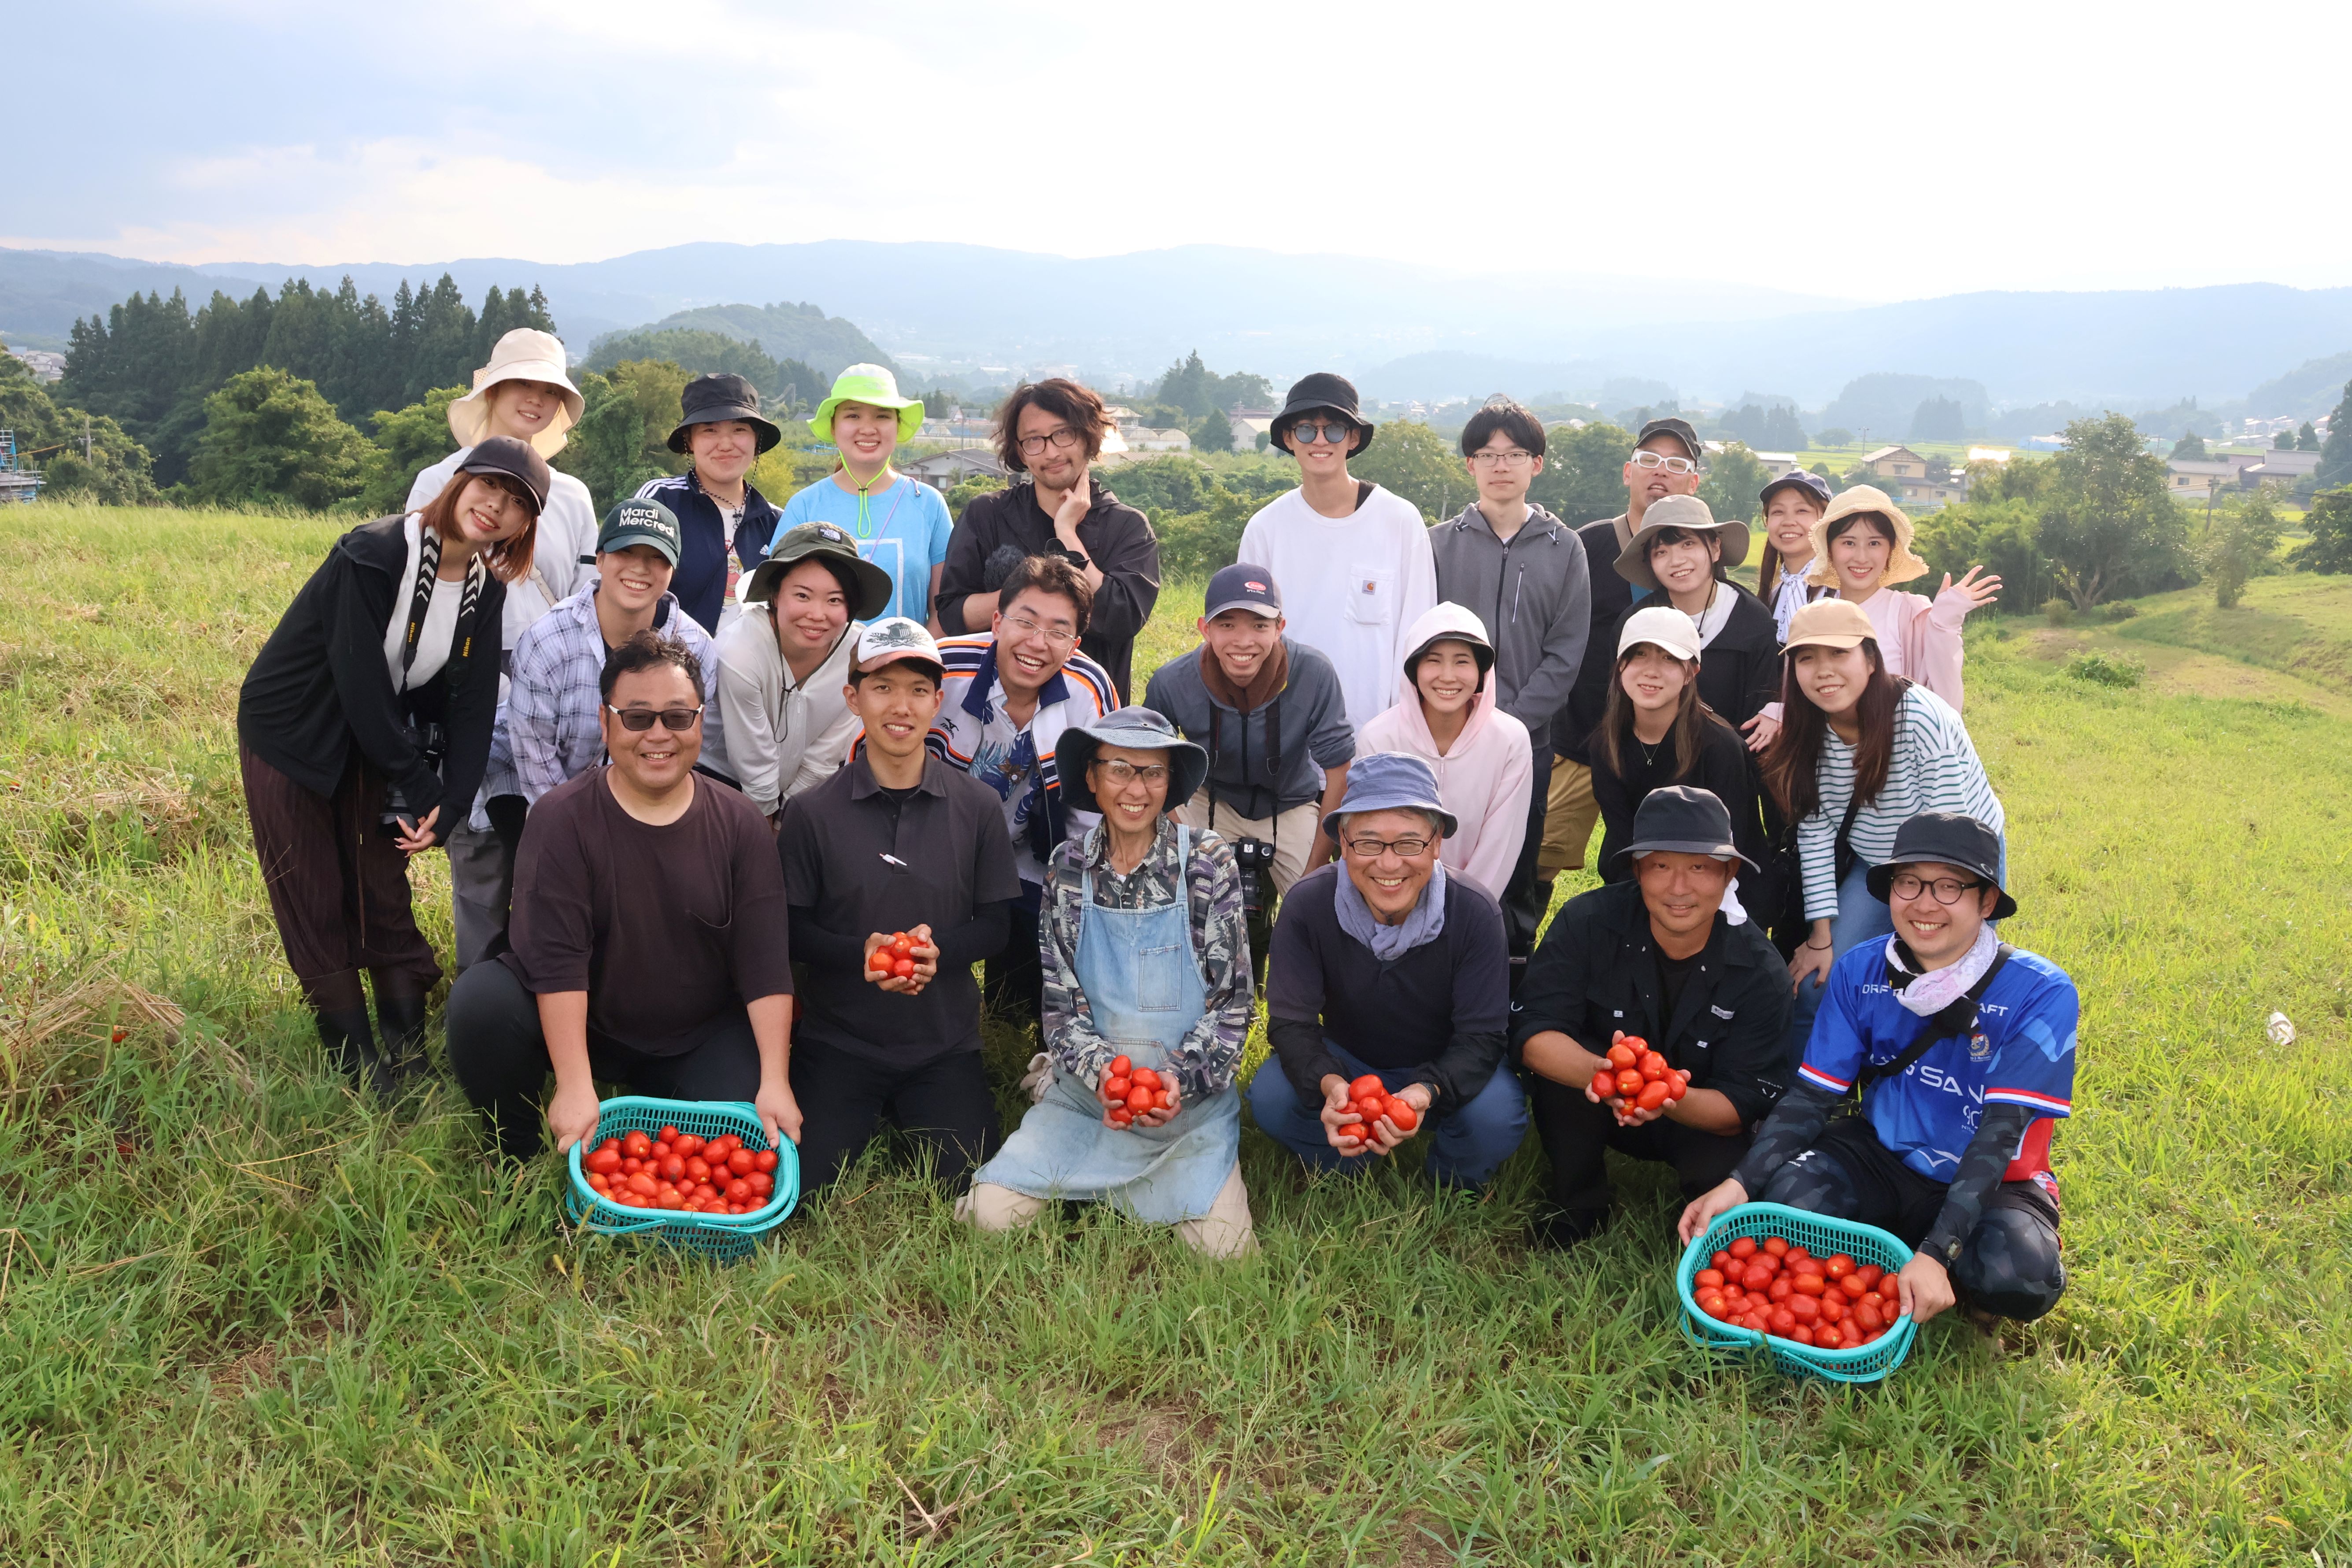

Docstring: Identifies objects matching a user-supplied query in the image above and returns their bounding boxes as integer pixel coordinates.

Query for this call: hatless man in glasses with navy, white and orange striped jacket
[927,555,1120,1023]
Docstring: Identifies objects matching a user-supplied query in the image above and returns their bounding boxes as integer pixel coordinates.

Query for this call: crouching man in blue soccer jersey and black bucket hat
[1682,811,2079,1326]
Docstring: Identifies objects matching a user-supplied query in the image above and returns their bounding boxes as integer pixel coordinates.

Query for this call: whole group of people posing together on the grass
[237,332,2077,1319]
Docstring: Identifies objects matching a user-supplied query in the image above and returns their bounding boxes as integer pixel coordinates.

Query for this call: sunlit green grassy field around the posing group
[0,508,2352,1568]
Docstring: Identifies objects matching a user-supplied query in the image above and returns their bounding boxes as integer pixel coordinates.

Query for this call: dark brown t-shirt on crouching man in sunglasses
[501,766,793,1055]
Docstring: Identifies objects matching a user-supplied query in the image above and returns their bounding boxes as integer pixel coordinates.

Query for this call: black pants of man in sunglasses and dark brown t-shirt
[449,959,760,1159]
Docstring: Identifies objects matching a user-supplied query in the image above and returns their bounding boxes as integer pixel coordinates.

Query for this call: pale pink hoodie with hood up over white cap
[1355,604,1536,898]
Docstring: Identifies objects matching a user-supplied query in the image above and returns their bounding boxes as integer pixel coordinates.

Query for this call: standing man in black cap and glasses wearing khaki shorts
[1536,416,1705,907]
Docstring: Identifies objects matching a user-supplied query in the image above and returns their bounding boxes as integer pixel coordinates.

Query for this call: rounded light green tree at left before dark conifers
[188,364,374,513]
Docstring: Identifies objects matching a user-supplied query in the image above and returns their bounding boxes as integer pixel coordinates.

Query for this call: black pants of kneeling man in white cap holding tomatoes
[793,1039,997,1192]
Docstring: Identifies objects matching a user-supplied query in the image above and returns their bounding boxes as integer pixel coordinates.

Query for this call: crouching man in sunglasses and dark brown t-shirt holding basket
[447,621,800,1159]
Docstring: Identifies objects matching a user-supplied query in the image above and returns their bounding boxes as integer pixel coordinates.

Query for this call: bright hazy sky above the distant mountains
[18,0,2352,301]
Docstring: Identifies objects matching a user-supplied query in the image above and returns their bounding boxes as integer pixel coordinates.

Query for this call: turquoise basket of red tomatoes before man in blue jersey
[1675,1204,1919,1382]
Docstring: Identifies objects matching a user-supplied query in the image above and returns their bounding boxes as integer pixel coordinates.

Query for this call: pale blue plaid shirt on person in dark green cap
[482,578,729,806]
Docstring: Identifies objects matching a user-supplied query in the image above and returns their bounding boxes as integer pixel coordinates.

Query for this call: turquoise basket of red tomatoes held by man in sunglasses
[565,1095,800,1262]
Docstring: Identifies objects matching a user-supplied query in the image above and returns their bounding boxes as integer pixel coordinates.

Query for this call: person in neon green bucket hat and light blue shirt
[779,364,955,635]
